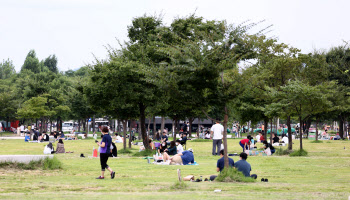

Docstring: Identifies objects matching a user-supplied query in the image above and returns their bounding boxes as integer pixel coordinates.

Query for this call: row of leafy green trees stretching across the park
[0,15,350,167]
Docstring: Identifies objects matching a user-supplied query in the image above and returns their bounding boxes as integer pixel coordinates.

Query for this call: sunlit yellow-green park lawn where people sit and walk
[0,139,350,199]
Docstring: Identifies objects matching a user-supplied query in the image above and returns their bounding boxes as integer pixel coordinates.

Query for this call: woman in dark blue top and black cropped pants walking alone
[96,126,115,179]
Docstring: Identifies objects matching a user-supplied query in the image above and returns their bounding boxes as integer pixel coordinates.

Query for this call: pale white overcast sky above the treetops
[0,0,350,71]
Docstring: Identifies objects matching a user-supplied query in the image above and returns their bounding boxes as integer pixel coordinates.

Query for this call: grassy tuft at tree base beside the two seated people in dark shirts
[215,167,256,183]
